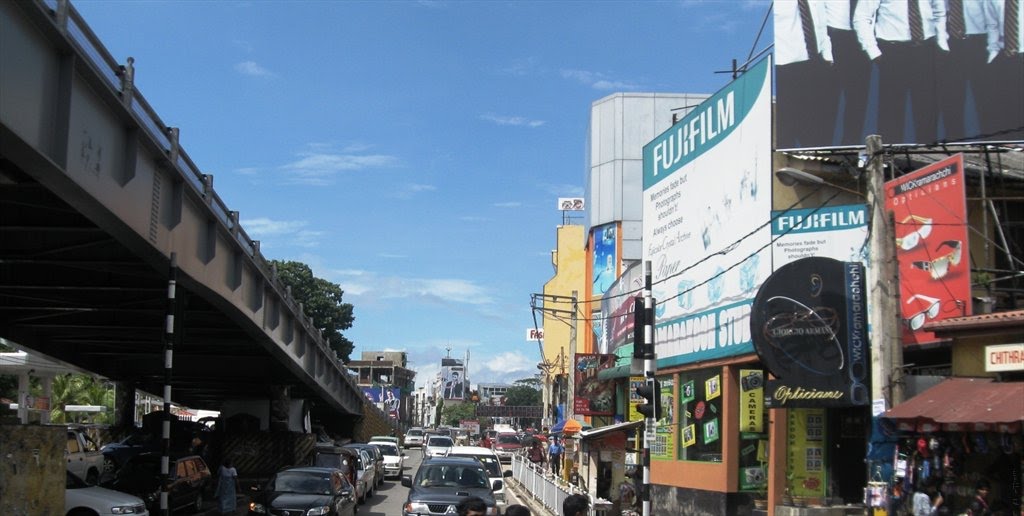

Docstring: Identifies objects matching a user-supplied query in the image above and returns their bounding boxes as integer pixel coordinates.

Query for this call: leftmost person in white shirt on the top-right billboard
[774,0,836,148]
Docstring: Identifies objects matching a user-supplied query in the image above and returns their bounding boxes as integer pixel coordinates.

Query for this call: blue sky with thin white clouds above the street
[72,0,771,386]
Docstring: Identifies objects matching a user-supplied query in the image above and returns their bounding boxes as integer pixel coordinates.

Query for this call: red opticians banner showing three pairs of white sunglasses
[886,155,971,344]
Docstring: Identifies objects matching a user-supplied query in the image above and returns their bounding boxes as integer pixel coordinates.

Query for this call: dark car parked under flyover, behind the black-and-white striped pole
[104,453,213,513]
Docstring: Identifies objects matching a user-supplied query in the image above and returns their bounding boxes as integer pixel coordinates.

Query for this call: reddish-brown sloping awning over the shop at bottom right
[882,378,1024,432]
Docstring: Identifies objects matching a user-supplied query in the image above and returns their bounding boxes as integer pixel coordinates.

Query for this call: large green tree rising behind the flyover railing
[270,260,355,363]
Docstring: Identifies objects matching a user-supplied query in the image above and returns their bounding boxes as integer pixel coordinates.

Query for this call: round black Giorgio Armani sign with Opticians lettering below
[751,257,870,409]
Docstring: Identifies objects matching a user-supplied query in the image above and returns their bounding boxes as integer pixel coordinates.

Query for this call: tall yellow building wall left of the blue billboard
[543,225,590,374]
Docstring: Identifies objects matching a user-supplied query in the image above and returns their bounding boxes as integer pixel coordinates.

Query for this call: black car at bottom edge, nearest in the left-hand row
[249,468,355,516]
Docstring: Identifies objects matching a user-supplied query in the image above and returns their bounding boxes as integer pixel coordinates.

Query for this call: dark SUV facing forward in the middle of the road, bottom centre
[401,457,502,516]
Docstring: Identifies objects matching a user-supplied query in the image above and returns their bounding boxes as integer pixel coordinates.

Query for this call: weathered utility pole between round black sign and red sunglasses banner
[864,134,903,410]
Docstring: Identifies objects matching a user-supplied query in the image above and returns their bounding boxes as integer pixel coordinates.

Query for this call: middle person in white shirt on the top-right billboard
[853,0,949,143]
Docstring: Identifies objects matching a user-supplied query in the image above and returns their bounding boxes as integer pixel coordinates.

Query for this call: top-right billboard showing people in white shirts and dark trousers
[772,0,1024,149]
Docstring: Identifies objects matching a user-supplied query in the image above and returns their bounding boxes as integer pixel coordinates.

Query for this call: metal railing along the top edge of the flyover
[36,0,361,389]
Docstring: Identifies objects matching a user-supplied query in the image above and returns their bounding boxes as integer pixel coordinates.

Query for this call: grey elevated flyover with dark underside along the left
[0,0,366,431]
